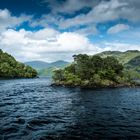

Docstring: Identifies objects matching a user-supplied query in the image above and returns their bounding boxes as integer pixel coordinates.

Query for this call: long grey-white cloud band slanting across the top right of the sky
[27,0,140,35]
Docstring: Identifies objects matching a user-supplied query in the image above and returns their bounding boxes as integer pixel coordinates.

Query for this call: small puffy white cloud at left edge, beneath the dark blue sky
[0,9,31,32]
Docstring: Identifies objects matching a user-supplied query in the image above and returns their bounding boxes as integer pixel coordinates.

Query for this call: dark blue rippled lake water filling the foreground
[0,78,140,140]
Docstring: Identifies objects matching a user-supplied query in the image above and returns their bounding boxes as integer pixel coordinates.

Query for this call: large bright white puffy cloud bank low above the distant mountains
[0,28,100,61]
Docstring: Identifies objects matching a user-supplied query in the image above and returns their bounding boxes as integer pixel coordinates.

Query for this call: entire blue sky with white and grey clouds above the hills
[0,0,140,62]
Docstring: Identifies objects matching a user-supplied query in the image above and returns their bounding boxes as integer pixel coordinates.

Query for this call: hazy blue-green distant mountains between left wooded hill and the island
[25,60,70,76]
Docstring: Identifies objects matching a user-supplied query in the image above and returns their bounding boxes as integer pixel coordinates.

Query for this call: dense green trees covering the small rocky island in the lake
[53,54,135,87]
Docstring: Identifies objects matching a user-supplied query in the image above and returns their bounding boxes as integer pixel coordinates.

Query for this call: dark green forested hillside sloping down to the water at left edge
[0,49,37,79]
